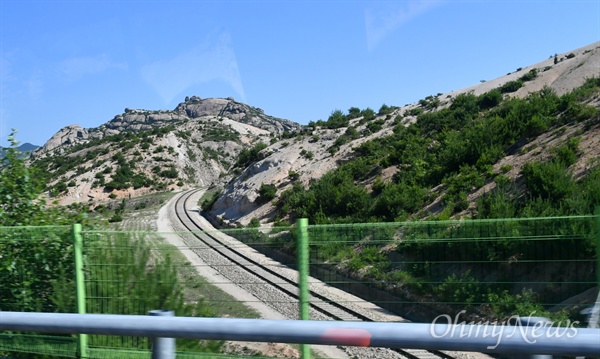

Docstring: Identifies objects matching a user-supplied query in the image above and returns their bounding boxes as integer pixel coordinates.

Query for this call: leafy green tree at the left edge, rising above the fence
[0,130,78,311]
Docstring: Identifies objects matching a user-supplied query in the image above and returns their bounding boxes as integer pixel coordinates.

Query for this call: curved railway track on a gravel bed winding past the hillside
[175,189,454,359]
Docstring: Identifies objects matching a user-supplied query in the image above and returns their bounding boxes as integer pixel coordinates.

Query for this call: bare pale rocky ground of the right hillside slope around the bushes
[211,42,600,225]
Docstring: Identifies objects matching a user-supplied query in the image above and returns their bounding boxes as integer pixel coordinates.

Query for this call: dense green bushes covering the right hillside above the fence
[277,78,600,224]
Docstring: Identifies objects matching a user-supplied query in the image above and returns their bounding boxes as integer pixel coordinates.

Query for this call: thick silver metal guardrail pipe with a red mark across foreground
[0,312,600,357]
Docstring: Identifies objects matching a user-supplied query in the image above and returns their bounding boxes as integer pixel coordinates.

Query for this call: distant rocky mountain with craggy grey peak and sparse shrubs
[31,96,302,204]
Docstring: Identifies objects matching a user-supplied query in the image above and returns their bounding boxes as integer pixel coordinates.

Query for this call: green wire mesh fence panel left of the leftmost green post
[0,226,76,356]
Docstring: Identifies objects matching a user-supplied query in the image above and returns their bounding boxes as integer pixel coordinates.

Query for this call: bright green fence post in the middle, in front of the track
[296,218,310,359]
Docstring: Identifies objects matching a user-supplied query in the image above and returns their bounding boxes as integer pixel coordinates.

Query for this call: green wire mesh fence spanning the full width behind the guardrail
[0,216,600,358]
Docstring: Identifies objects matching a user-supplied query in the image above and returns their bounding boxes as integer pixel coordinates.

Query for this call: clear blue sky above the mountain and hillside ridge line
[0,0,600,146]
